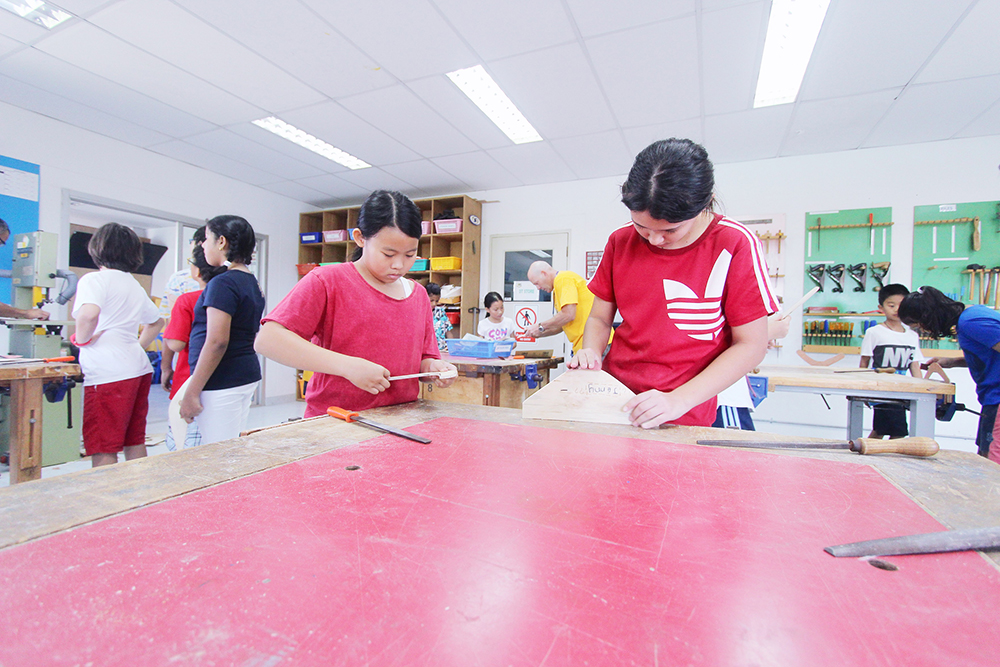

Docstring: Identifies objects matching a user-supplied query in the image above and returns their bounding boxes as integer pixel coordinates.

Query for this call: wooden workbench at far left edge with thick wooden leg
[0,363,80,484]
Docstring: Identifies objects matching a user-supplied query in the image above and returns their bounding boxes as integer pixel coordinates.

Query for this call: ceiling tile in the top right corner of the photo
[916,2,1000,83]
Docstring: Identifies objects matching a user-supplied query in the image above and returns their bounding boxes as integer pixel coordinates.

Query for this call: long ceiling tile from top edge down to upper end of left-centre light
[89,0,325,113]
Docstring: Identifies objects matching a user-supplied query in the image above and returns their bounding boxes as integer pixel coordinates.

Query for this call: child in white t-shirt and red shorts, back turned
[72,222,163,468]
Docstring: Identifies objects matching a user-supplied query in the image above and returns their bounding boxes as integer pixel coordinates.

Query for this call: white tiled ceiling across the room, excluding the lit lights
[0,0,1000,206]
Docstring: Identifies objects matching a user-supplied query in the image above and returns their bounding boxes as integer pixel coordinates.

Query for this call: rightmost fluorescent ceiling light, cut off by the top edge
[753,0,830,109]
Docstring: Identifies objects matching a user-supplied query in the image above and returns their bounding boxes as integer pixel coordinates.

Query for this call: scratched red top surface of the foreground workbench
[0,418,1000,667]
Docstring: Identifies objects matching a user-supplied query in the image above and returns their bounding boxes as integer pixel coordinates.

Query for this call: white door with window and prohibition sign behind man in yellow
[490,232,573,359]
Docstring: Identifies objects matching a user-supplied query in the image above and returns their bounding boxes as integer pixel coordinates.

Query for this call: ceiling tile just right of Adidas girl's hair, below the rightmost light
[704,104,792,164]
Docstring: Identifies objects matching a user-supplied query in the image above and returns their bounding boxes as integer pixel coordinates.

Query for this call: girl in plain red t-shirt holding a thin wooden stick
[254,190,457,417]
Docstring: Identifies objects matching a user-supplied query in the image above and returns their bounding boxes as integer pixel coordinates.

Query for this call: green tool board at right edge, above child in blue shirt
[913,201,1000,308]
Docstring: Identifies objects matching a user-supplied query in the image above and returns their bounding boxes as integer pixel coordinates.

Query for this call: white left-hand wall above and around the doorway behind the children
[0,103,311,403]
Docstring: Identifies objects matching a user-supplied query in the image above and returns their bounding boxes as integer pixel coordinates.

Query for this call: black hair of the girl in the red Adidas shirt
[622,138,715,222]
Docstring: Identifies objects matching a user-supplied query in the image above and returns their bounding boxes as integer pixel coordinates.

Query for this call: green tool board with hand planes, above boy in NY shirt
[802,207,893,354]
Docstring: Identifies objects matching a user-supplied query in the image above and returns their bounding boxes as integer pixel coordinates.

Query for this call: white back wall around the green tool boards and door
[474,137,1000,451]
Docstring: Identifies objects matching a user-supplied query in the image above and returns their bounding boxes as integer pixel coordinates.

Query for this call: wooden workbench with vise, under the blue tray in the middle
[420,354,563,409]
